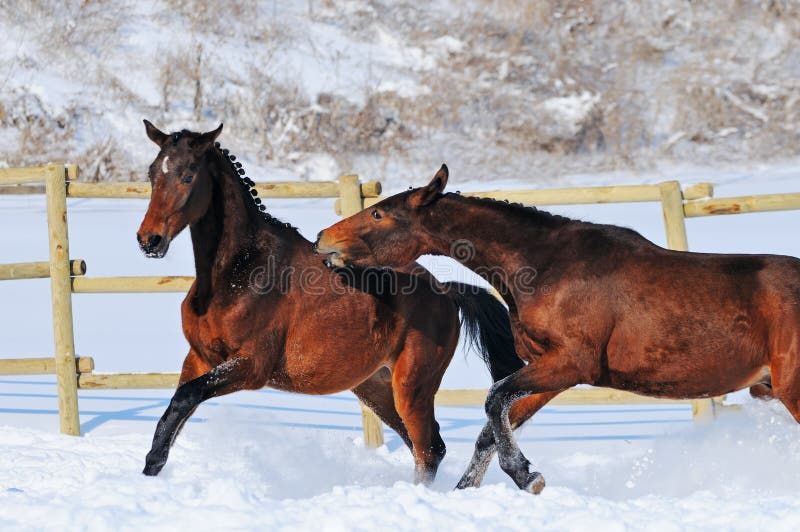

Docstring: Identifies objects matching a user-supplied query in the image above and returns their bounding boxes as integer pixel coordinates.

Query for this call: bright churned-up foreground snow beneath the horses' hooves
[0,399,800,530]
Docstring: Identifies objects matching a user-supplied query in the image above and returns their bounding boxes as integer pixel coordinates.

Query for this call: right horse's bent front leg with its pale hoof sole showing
[486,351,581,494]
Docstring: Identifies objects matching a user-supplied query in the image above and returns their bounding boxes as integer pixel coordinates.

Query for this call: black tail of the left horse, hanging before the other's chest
[442,281,525,382]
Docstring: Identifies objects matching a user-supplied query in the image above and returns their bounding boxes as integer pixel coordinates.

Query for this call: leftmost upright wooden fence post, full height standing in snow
[45,164,81,436]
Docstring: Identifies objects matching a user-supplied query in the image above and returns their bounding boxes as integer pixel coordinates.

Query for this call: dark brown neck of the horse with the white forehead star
[191,152,284,308]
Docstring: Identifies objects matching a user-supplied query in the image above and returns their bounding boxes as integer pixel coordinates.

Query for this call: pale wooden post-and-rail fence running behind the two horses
[0,165,800,446]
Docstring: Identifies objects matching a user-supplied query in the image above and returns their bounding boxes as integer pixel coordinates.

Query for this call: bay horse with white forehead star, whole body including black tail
[137,120,523,483]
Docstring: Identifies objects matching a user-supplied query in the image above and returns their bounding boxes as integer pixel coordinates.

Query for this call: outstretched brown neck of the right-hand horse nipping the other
[424,194,571,297]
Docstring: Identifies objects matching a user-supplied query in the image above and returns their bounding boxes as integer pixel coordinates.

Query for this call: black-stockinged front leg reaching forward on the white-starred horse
[142,357,253,476]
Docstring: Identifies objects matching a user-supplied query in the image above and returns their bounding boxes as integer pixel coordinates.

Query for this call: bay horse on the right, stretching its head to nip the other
[317,165,800,493]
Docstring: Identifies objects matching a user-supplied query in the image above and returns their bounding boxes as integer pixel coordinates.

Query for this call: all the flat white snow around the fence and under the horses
[0,163,800,531]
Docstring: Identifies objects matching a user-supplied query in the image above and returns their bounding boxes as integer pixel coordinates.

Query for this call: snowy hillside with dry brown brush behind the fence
[0,0,800,182]
